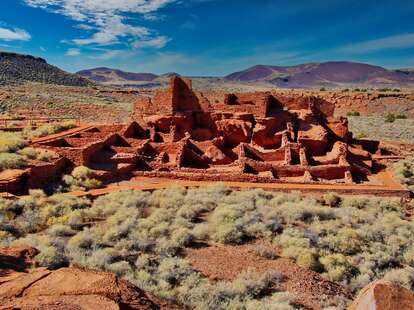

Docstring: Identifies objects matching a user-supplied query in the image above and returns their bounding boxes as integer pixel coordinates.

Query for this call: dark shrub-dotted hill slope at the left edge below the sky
[0,52,93,86]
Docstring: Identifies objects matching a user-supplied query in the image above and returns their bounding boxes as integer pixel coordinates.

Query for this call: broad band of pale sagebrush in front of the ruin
[0,186,414,309]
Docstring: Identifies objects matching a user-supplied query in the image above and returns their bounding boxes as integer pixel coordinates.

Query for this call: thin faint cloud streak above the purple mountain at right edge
[337,33,414,54]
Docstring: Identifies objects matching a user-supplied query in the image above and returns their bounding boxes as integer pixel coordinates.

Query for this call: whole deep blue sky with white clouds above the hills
[0,0,414,76]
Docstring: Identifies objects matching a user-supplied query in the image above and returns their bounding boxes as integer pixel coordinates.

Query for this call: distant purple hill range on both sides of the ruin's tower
[77,61,414,89]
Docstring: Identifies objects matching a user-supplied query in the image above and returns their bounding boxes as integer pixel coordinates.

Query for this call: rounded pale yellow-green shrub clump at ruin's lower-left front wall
[63,166,101,191]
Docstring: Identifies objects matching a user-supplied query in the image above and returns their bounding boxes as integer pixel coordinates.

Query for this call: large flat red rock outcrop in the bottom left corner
[0,247,175,310]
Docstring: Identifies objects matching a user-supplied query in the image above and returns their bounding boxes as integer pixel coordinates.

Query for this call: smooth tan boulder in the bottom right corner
[348,280,414,310]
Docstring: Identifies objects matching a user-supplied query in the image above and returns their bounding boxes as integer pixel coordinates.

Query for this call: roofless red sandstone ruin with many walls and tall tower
[21,77,378,190]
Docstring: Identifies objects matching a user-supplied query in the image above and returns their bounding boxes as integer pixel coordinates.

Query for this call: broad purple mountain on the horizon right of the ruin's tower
[225,61,414,88]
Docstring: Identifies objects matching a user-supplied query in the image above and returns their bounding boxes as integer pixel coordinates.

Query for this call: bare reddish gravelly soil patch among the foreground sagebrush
[186,244,352,309]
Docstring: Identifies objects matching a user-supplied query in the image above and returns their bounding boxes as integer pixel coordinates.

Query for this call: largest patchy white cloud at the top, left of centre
[24,0,173,48]
